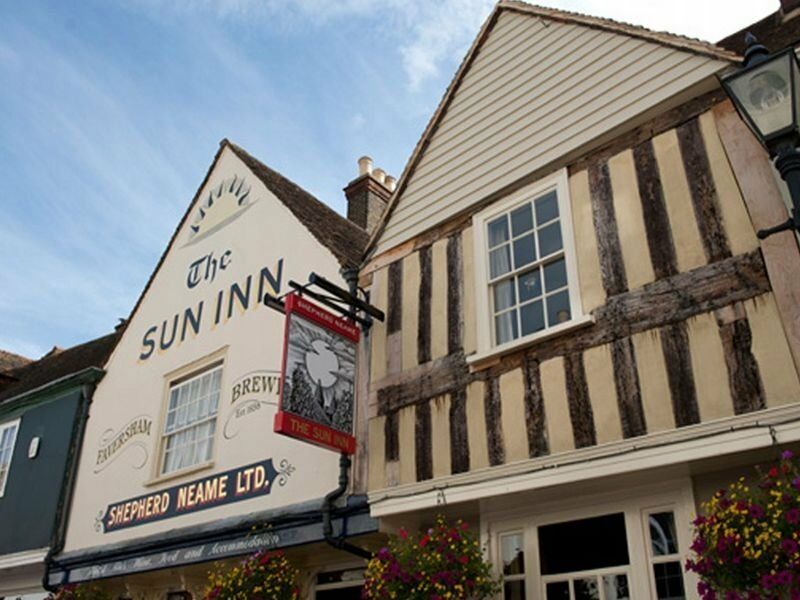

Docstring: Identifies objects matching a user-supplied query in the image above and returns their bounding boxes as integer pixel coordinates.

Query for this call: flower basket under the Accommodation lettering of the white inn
[203,550,300,600]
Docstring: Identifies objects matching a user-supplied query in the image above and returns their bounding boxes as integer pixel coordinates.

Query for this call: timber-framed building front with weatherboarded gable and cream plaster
[360,0,800,599]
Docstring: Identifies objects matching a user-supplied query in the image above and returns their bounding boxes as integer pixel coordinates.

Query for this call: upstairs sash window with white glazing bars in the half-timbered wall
[474,172,582,351]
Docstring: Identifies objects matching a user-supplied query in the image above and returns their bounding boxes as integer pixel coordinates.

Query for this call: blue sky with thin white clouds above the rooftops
[0,0,778,357]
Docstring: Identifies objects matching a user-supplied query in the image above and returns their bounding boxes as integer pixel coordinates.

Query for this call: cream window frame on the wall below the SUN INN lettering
[153,352,225,485]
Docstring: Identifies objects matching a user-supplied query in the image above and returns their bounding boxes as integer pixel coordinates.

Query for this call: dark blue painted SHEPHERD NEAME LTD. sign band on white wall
[101,458,294,533]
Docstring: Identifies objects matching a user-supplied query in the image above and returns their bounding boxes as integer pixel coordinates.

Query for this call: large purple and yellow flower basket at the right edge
[686,451,800,600]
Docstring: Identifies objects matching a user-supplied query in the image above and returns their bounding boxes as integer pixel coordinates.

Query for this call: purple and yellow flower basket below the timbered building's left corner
[364,516,500,600]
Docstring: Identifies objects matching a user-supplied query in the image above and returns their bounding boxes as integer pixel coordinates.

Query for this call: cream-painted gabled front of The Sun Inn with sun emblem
[54,140,377,598]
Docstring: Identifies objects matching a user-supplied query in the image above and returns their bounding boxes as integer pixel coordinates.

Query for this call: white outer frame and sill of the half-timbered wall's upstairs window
[467,169,592,362]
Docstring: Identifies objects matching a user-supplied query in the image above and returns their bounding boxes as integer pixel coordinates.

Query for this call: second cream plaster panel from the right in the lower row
[687,313,733,421]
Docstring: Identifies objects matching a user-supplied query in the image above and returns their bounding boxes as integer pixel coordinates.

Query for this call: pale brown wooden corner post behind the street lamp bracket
[714,101,800,373]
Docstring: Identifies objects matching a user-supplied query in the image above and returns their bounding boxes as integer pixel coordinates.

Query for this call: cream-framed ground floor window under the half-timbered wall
[487,486,693,600]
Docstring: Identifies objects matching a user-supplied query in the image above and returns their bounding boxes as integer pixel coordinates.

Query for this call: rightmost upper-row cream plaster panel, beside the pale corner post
[699,111,758,255]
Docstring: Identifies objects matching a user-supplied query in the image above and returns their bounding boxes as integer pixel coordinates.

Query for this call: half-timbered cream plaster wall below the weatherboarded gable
[365,105,800,493]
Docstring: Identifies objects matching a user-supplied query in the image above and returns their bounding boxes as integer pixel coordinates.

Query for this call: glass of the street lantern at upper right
[727,54,794,138]
